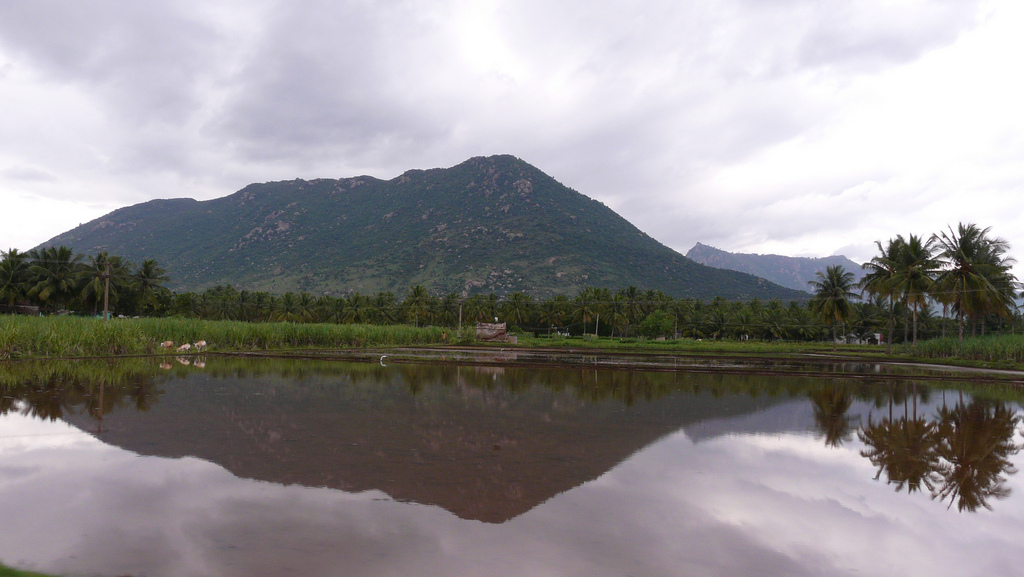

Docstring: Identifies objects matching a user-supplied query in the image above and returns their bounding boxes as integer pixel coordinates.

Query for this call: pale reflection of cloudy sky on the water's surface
[0,407,1024,577]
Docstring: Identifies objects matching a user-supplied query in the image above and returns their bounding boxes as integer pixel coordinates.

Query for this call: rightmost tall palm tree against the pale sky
[933,222,1020,341]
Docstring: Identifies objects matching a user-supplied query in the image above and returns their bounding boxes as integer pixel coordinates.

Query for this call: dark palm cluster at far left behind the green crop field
[0,246,170,316]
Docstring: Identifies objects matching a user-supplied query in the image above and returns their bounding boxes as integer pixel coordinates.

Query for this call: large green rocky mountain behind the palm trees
[44,156,807,299]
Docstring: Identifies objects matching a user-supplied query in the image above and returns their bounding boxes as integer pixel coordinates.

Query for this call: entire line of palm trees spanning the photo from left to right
[0,224,1022,344]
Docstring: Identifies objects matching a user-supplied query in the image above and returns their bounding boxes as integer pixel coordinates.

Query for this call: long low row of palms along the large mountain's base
[153,286,882,340]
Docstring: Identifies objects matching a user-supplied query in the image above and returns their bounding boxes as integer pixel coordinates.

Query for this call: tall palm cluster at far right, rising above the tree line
[861,223,1021,343]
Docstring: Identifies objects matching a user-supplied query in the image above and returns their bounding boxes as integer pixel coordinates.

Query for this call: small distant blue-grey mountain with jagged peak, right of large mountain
[686,243,864,290]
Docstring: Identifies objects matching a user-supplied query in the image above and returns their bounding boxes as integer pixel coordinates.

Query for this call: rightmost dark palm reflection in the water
[932,400,1021,511]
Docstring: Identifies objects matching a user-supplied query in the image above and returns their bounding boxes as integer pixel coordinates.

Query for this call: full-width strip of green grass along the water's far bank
[6,316,1024,369]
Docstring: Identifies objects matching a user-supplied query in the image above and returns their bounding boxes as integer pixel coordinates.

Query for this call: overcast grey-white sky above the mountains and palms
[0,0,1024,260]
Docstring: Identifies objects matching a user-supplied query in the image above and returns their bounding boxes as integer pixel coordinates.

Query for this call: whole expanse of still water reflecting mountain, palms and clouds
[0,358,1024,577]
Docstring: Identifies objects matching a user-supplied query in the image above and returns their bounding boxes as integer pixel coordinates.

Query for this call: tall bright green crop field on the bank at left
[0,316,445,359]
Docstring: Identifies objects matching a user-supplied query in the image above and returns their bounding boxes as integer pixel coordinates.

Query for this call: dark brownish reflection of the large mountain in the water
[70,366,782,523]
